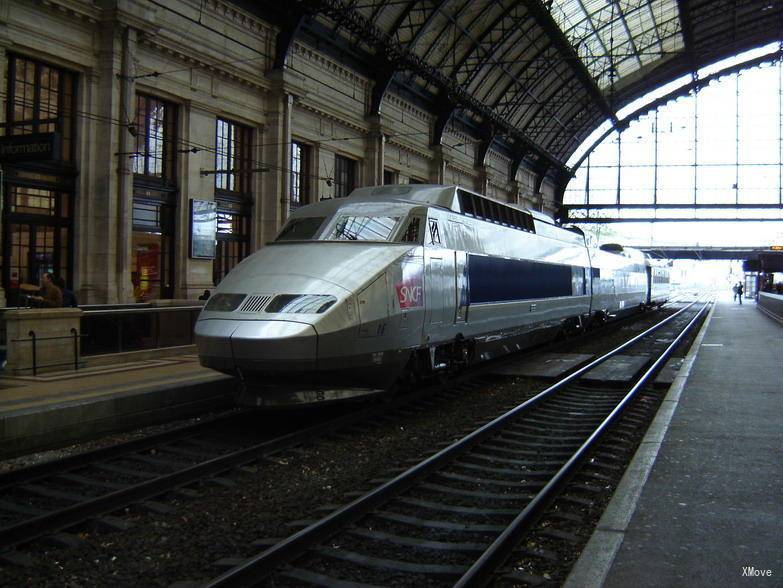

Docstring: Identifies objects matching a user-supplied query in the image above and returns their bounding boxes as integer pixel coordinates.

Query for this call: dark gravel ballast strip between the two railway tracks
[0,313,692,587]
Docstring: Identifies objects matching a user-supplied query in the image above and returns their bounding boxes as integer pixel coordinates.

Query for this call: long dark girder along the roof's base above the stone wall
[305,0,566,168]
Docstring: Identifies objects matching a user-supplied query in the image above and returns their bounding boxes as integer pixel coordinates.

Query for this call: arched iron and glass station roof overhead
[240,0,783,183]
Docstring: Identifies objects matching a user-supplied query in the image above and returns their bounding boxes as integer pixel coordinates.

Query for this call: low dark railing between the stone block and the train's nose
[81,305,202,356]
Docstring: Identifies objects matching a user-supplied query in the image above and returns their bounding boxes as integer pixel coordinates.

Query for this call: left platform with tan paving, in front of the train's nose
[0,349,235,459]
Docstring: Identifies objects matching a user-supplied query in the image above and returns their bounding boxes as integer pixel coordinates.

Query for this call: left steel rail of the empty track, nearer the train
[206,301,696,588]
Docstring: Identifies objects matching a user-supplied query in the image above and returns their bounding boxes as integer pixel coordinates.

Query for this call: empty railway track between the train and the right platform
[201,303,709,588]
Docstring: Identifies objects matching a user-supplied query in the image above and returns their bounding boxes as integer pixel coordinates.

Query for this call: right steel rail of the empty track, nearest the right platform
[454,302,710,588]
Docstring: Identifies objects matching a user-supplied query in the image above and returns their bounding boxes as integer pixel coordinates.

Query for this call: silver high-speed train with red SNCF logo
[196,185,669,405]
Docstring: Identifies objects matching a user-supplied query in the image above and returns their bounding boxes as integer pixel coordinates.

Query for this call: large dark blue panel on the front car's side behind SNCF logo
[468,255,583,304]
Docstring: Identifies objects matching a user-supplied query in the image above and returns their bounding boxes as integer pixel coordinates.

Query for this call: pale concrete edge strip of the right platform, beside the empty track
[563,304,716,588]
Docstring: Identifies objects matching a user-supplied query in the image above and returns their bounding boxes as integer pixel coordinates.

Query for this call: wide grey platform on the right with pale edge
[565,301,783,588]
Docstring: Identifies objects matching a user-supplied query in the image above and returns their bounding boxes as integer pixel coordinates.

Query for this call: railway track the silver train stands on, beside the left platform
[0,300,700,576]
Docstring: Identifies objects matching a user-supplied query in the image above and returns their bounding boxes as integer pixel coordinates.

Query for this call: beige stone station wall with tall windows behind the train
[0,0,554,303]
